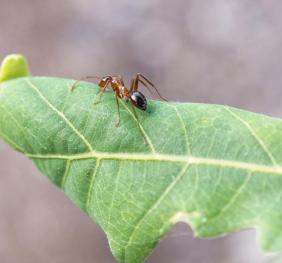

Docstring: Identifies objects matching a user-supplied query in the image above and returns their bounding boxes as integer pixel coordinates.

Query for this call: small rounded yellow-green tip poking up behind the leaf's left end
[0,54,30,83]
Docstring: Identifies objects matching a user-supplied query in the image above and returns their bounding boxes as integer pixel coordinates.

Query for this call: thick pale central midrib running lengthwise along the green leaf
[25,151,282,175]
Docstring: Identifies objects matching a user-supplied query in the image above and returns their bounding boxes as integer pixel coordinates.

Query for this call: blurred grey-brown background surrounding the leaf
[0,0,282,263]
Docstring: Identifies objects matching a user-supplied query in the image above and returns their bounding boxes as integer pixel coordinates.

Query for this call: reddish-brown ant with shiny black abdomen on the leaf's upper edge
[71,73,167,143]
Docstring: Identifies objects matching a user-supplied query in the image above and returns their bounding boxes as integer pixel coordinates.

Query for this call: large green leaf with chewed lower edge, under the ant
[0,77,282,263]
